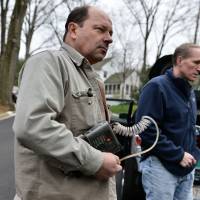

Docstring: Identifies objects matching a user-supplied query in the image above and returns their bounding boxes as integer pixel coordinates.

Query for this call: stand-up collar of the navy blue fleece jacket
[165,68,192,99]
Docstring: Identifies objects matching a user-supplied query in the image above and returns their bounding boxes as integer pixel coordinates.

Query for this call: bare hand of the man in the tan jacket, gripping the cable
[95,153,122,180]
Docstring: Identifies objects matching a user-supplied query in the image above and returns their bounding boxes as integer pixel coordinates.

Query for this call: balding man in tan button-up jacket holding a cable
[13,6,121,200]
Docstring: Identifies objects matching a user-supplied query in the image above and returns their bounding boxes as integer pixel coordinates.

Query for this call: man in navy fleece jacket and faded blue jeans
[136,44,200,200]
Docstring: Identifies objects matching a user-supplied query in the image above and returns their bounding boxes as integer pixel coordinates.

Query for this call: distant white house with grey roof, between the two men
[104,69,140,99]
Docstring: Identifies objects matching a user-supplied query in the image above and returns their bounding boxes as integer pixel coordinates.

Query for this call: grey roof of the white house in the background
[105,69,134,84]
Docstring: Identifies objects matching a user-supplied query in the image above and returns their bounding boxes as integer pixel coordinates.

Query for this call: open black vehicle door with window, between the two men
[107,98,145,200]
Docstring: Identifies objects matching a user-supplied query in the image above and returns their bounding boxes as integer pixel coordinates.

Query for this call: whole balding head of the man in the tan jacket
[64,6,112,64]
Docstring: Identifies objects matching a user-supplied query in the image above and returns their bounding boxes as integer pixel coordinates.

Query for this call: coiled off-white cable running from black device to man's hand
[113,116,160,161]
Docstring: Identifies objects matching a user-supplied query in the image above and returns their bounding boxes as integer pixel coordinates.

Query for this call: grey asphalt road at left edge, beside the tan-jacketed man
[0,117,15,200]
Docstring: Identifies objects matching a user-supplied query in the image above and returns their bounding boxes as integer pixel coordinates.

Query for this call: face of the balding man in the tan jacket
[73,8,112,64]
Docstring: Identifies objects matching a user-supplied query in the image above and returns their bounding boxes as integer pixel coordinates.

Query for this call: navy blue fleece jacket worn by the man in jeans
[136,69,200,176]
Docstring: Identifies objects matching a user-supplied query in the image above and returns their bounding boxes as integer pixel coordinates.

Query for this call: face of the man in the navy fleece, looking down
[177,48,200,81]
